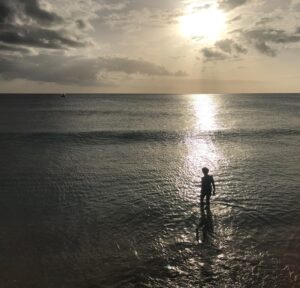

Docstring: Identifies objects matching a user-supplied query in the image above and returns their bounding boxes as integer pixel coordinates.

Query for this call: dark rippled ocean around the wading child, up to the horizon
[0,94,300,288]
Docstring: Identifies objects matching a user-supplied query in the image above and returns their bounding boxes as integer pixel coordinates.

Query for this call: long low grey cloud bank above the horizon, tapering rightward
[0,55,187,85]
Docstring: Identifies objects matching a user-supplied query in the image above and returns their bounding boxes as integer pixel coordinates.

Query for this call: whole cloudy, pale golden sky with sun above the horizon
[0,0,300,93]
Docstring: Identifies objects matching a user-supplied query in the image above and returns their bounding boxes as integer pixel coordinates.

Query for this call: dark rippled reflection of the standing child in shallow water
[196,205,214,244]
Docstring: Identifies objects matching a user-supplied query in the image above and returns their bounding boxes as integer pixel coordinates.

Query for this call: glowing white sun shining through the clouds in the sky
[180,7,226,43]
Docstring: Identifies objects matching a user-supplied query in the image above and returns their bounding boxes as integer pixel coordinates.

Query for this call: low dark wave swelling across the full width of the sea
[0,129,300,144]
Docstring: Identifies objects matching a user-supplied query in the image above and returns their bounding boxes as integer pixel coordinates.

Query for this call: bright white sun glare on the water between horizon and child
[177,94,222,202]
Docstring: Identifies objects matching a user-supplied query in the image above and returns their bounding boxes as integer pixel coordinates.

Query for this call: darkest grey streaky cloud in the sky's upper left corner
[0,0,88,52]
